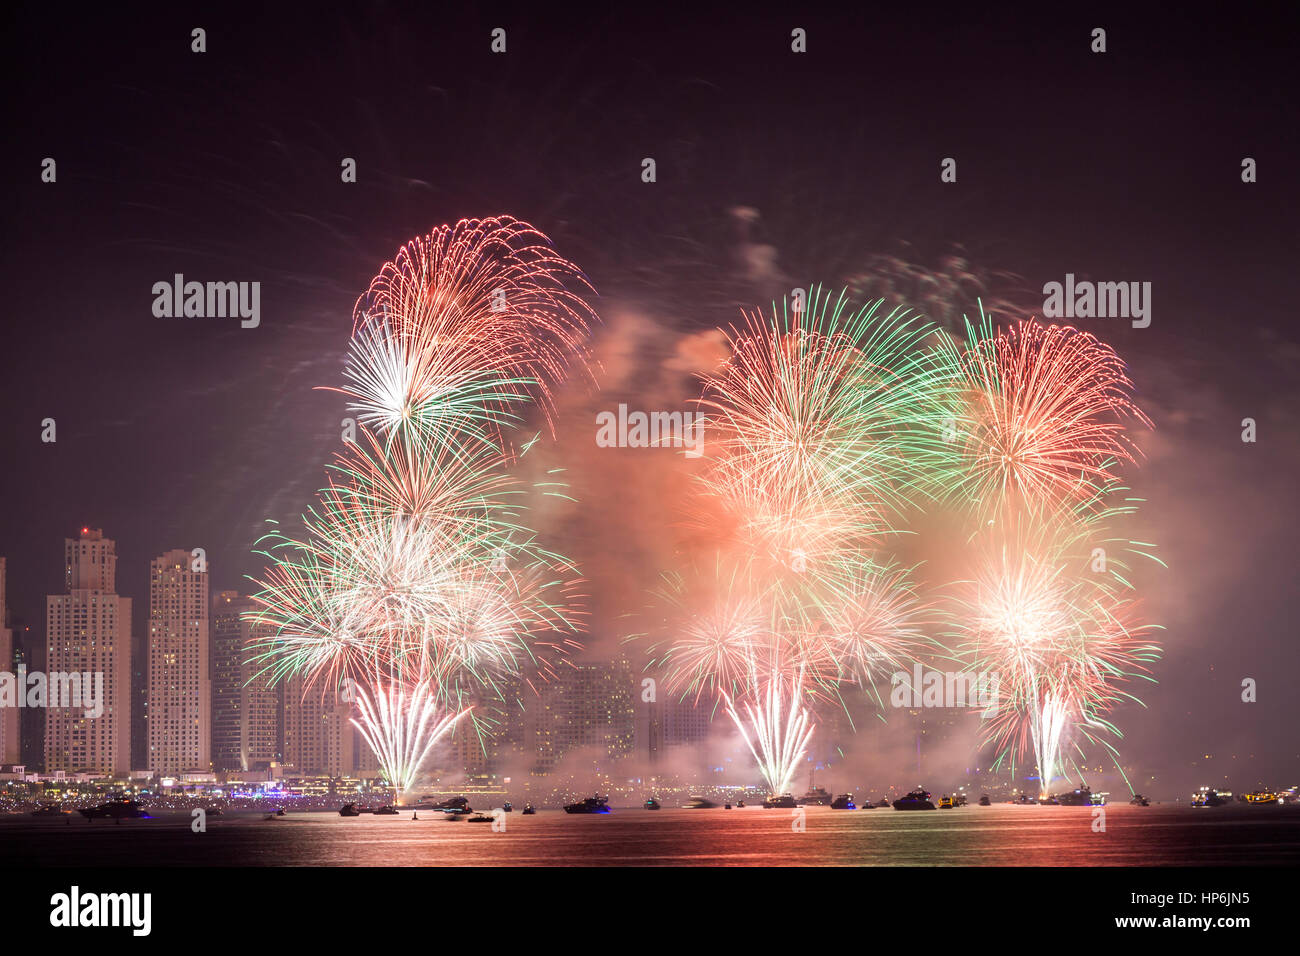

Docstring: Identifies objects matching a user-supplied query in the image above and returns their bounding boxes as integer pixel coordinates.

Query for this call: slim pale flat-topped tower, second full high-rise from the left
[147,549,212,775]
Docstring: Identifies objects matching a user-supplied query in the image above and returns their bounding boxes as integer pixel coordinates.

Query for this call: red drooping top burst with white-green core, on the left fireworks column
[338,216,595,446]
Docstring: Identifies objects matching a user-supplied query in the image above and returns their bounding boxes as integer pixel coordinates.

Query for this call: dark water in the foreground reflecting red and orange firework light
[0,804,1300,866]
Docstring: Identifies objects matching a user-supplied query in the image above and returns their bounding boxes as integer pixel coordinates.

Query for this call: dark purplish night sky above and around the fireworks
[0,4,1300,790]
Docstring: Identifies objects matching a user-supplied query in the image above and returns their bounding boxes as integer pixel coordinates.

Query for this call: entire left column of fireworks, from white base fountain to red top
[248,217,594,796]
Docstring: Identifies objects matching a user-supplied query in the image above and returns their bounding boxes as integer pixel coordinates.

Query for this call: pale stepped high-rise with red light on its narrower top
[44,528,131,775]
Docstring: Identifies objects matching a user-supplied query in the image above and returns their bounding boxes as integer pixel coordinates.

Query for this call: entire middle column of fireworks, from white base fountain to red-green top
[651,287,950,793]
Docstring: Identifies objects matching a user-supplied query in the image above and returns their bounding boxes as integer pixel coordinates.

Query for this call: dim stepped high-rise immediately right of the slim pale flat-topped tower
[211,591,281,770]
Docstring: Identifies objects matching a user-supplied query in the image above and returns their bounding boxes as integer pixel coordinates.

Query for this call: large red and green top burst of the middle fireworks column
[698,287,946,572]
